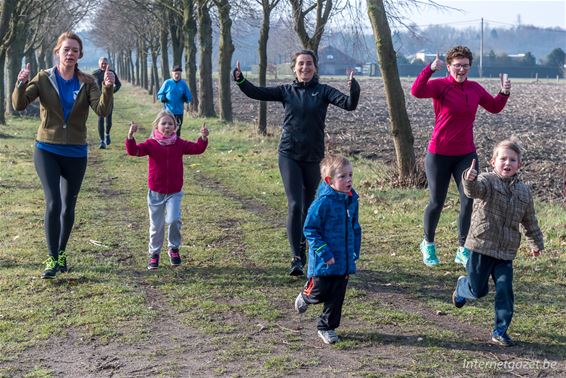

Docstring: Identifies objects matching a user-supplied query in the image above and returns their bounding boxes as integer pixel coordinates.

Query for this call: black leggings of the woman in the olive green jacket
[33,147,87,259]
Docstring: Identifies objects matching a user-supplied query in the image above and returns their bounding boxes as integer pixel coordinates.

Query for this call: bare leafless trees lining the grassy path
[0,0,454,181]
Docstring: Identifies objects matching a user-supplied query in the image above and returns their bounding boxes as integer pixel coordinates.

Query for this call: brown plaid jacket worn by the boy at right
[462,170,544,260]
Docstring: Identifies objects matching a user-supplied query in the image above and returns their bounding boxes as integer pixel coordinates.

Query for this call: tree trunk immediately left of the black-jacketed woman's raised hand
[216,0,234,122]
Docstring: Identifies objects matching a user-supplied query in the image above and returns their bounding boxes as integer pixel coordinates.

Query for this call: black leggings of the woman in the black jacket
[279,155,320,264]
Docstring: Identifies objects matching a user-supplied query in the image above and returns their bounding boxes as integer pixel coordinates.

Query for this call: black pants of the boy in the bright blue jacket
[301,276,348,331]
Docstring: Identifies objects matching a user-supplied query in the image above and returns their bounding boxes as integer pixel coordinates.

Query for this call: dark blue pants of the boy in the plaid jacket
[456,251,515,335]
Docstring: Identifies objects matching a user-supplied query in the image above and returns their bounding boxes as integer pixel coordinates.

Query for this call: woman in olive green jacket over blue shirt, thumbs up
[12,32,114,278]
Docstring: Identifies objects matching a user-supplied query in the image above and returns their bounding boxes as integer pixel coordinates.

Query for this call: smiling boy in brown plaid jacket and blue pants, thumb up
[452,140,544,346]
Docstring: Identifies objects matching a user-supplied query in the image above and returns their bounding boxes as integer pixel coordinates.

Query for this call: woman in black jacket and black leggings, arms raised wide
[233,50,360,276]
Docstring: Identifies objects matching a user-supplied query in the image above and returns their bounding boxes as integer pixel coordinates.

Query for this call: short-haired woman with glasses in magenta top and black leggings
[411,46,511,266]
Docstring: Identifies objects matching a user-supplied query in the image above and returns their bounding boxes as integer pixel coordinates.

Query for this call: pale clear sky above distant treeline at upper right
[406,0,566,29]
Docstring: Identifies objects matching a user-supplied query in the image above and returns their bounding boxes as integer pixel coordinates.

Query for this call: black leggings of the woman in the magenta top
[424,152,479,246]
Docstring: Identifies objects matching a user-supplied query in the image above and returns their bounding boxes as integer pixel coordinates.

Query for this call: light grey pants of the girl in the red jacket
[147,190,183,256]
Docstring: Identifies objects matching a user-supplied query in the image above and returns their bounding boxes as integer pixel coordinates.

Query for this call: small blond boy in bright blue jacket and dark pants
[295,155,362,344]
